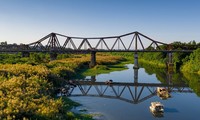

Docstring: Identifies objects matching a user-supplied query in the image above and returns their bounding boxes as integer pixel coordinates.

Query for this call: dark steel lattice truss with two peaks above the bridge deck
[28,32,168,51]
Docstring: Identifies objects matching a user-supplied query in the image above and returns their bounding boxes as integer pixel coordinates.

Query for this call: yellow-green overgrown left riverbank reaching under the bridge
[0,53,124,120]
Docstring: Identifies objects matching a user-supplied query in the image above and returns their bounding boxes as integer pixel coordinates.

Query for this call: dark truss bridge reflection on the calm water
[65,69,193,104]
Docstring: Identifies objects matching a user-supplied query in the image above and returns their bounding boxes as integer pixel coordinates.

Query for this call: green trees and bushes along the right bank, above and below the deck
[112,41,200,75]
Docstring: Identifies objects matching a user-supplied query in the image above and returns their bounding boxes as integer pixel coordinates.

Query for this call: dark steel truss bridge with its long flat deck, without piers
[0,31,195,53]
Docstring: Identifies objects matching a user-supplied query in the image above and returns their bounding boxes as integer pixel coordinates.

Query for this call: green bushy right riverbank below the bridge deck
[139,48,200,75]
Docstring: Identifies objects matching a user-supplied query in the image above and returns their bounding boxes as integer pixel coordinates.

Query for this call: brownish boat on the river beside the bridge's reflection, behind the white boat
[157,87,171,99]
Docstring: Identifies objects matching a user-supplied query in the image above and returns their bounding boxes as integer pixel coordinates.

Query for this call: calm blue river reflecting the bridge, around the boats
[69,64,200,120]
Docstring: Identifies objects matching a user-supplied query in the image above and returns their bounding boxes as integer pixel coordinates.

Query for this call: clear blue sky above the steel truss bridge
[0,0,200,44]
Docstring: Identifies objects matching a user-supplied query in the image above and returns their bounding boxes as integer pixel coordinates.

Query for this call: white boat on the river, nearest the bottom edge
[149,102,164,113]
